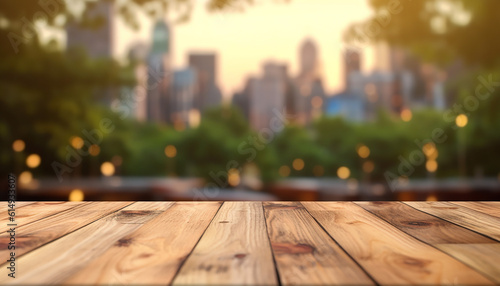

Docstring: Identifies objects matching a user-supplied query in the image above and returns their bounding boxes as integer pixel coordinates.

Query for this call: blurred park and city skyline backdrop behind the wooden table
[0,0,500,201]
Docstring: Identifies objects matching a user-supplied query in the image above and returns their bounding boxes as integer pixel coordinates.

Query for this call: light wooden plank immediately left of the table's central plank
[63,202,221,285]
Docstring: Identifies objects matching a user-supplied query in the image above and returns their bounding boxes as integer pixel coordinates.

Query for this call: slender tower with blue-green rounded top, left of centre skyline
[146,20,172,122]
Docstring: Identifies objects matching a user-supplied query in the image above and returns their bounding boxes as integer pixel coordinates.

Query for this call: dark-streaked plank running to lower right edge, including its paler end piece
[356,202,500,282]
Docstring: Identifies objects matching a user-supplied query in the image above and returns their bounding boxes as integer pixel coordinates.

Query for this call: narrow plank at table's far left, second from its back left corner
[0,202,83,233]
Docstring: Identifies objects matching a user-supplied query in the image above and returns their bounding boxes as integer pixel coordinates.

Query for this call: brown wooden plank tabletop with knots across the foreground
[0,202,500,285]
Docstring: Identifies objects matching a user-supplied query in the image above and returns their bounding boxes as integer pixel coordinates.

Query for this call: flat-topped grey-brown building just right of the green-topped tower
[188,53,222,111]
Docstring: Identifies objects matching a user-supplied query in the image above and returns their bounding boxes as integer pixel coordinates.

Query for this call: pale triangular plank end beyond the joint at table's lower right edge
[436,243,500,284]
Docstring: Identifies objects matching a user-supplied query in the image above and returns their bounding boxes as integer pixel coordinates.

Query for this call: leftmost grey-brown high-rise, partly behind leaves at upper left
[66,1,114,58]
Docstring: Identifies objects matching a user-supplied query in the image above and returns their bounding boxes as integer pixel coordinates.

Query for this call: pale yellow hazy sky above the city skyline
[115,0,373,97]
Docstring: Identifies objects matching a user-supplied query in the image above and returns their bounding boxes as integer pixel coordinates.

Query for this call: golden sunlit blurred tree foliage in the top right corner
[346,0,500,68]
